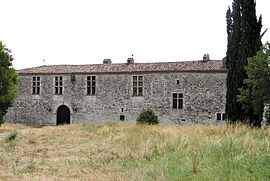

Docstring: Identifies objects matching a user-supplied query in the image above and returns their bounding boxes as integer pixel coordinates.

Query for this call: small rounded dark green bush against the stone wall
[136,109,159,124]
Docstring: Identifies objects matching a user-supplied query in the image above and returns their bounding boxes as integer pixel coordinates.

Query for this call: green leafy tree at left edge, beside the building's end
[0,41,18,126]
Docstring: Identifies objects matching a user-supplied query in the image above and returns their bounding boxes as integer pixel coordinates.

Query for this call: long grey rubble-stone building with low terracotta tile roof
[5,60,227,125]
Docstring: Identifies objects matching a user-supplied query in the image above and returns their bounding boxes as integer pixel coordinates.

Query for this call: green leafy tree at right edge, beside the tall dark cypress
[237,43,270,124]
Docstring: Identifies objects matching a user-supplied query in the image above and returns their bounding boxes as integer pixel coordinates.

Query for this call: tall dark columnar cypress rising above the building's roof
[226,0,262,122]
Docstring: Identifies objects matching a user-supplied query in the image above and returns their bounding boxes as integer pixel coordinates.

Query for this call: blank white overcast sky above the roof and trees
[0,0,270,69]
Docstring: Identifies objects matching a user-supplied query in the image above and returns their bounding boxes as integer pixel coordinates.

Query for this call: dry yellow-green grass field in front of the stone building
[0,123,270,180]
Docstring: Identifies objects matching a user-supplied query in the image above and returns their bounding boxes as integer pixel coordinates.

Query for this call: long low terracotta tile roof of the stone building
[17,60,226,74]
